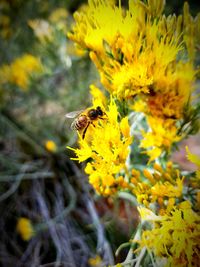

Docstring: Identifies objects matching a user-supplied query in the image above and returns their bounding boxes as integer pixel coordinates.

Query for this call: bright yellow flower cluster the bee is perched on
[70,96,132,195]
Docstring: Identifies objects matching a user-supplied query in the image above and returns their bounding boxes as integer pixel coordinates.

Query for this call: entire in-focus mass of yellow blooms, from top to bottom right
[68,0,200,266]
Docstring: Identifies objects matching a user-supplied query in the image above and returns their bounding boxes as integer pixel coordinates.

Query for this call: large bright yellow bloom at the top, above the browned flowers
[68,0,198,101]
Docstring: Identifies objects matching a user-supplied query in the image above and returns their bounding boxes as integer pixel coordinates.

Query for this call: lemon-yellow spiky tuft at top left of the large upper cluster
[68,0,136,51]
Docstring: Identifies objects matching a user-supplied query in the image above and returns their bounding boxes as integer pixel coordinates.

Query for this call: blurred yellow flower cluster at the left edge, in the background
[0,54,42,90]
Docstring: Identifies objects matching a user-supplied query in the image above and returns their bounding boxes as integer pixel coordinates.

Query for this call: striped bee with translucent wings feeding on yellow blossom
[65,106,105,139]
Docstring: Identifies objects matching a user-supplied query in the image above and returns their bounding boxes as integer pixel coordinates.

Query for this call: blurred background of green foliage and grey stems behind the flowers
[0,0,200,267]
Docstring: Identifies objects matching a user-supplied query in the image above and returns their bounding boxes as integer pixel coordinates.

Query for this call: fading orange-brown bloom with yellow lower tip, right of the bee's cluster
[132,63,195,161]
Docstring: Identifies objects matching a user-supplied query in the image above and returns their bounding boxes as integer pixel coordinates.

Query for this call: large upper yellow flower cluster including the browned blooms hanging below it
[68,0,200,160]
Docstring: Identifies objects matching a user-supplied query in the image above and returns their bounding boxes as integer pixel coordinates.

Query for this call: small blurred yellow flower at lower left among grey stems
[16,217,34,241]
